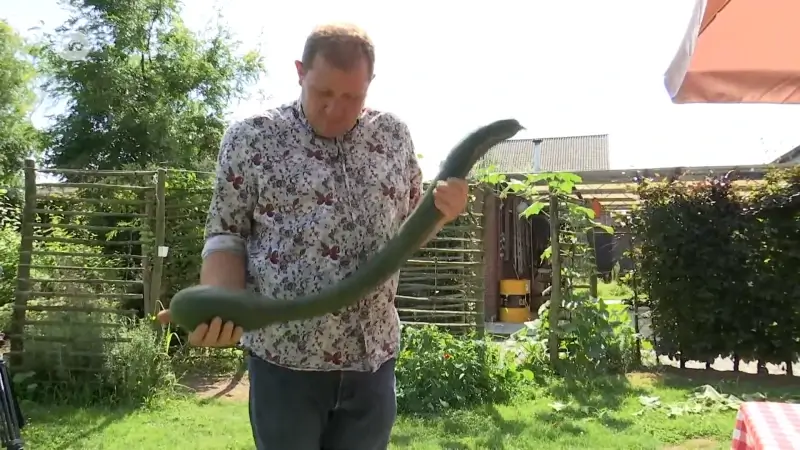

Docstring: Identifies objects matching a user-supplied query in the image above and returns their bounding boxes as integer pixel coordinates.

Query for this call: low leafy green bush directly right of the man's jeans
[396,326,531,413]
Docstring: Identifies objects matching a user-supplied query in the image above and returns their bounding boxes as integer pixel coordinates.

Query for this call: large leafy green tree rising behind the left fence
[41,0,264,169]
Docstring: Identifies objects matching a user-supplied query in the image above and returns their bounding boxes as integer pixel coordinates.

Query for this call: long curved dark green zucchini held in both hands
[169,119,523,331]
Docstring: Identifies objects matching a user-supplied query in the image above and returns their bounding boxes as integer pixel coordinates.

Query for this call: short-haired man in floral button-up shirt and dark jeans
[161,25,467,450]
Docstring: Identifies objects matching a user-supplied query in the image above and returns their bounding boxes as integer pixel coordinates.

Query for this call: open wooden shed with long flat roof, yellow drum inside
[468,155,791,334]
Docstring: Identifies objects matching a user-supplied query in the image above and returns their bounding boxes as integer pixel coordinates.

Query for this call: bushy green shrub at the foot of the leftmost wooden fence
[13,313,175,405]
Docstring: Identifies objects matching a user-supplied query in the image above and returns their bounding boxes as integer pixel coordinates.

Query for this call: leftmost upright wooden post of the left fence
[11,158,36,366]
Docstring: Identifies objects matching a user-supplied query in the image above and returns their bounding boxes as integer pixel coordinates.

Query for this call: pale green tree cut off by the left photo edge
[0,20,41,186]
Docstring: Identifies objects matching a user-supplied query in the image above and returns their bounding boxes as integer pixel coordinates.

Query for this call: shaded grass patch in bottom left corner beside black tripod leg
[22,402,137,450]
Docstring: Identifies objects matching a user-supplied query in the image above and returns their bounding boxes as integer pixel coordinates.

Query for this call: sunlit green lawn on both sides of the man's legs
[24,369,798,450]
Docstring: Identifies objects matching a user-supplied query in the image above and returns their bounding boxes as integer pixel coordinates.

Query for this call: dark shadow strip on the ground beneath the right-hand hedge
[654,366,800,401]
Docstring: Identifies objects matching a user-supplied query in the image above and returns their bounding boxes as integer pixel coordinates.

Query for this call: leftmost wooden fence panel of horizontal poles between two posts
[9,160,165,378]
